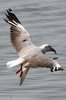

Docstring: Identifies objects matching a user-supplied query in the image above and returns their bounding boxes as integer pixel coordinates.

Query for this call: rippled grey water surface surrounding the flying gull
[0,0,66,100]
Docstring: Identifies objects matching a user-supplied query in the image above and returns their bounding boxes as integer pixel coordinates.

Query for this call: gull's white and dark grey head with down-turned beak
[40,44,57,54]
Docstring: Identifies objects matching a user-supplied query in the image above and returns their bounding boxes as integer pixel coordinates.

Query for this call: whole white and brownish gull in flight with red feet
[4,9,64,85]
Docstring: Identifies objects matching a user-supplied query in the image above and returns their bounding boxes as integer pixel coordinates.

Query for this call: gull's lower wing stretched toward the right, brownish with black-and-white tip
[28,53,64,72]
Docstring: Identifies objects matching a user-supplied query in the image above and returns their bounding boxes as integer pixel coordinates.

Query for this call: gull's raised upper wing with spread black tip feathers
[4,9,34,55]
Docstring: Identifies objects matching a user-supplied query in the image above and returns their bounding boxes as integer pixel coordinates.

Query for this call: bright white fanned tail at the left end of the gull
[6,57,24,68]
